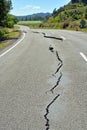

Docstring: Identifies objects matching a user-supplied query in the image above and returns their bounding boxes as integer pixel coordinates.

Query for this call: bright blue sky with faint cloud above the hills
[10,0,70,16]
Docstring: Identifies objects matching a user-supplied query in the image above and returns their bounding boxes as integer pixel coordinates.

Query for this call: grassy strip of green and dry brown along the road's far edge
[18,20,87,32]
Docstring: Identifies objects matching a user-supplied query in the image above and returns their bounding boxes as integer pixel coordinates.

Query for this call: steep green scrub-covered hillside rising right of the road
[43,0,87,29]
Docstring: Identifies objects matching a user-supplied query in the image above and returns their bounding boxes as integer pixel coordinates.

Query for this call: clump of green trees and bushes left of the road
[0,0,17,27]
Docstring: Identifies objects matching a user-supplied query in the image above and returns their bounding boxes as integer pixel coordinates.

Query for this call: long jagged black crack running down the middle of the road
[42,33,63,130]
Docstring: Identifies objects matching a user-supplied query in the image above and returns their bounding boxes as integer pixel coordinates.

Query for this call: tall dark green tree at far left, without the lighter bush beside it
[0,0,12,26]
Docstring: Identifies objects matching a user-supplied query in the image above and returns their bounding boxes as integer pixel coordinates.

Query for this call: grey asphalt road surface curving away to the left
[0,26,87,130]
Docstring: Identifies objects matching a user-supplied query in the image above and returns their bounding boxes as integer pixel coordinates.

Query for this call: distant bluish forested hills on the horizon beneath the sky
[16,13,51,21]
